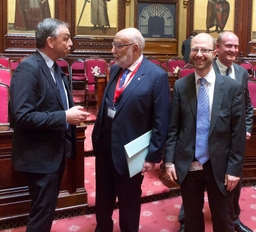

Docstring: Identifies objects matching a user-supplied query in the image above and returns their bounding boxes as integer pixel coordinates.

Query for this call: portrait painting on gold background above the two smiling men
[194,0,235,37]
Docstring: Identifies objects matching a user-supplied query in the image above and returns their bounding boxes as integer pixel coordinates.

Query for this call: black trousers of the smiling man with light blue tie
[181,161,234,232]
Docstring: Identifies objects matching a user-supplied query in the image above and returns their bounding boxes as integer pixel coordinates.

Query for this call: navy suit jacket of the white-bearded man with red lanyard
[92,58,170,174]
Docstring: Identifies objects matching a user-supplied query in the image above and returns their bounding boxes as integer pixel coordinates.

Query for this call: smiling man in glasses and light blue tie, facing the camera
[165,33,246,232]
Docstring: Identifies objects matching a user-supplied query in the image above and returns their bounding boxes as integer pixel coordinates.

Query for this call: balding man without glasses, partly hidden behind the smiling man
[179,32,253,232]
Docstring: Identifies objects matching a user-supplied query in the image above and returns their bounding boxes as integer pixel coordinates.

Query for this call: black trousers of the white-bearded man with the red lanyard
[95,133,143,232]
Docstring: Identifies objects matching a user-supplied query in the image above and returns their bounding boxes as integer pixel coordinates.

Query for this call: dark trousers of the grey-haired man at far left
[24,156,66,232]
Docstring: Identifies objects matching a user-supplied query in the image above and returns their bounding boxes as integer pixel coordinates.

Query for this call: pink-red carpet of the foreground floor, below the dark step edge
[2,187,256,232]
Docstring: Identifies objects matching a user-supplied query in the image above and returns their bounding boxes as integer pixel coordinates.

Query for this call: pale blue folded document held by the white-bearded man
[124,130,152,177]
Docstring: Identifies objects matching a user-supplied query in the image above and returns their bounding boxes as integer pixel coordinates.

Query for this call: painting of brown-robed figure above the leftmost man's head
[8,0,54,33]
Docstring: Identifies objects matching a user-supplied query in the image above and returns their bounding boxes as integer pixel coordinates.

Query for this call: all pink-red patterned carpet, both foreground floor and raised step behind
[0,110,256,232]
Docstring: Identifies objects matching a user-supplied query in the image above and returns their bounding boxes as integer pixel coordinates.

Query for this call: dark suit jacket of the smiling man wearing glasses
[165,73,245,194]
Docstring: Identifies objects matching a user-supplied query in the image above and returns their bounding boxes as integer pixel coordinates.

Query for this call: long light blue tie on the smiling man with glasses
[195,78,210,164]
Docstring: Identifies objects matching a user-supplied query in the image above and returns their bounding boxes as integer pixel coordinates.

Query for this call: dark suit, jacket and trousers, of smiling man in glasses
[165,71,245,232]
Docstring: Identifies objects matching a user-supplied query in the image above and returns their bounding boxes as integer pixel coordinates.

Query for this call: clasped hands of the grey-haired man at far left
[66,106,90,126]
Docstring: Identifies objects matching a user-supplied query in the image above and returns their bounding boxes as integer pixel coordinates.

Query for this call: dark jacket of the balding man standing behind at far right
[213,61,253,133]
